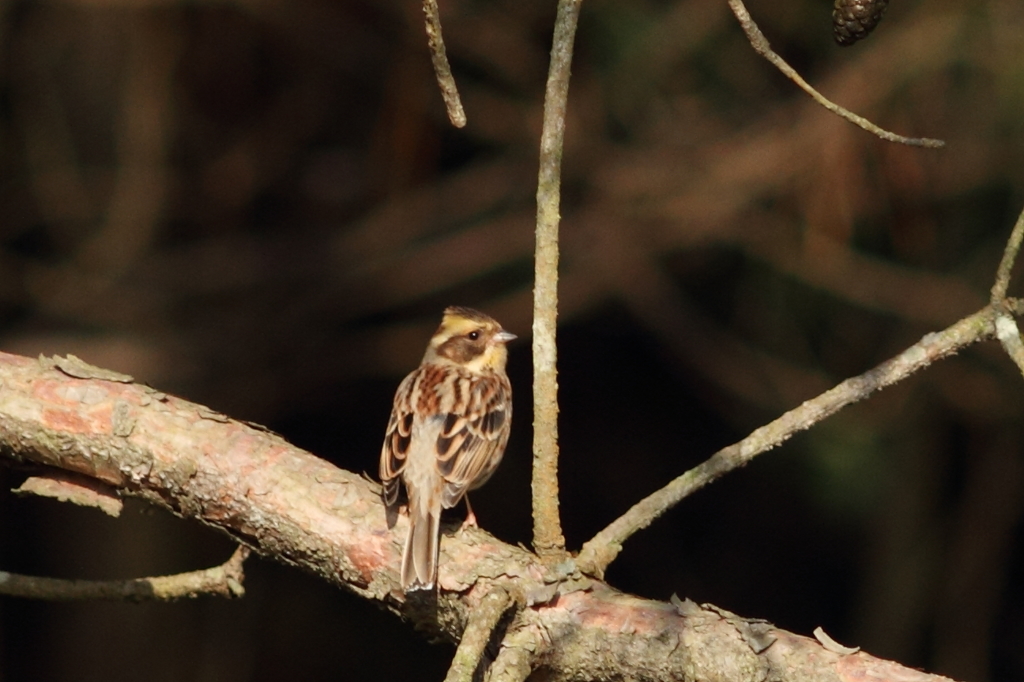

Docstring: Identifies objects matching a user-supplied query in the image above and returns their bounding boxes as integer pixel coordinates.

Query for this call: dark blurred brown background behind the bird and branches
[0,0,1024,682]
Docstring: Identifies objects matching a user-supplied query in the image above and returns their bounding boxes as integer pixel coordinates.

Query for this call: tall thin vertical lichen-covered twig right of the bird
[532,0,582,559]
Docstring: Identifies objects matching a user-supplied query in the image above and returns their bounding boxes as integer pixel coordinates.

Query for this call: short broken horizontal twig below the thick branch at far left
[0,545,249,601]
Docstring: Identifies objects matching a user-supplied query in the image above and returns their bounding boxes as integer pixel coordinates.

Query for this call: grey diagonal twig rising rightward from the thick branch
[577,299,1021,577]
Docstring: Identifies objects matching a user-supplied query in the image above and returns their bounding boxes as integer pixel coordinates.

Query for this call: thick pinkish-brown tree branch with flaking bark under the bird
[0,353,966,682]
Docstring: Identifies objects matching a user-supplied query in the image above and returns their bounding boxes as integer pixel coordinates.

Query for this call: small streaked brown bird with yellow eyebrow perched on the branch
[380,306,516,592]
